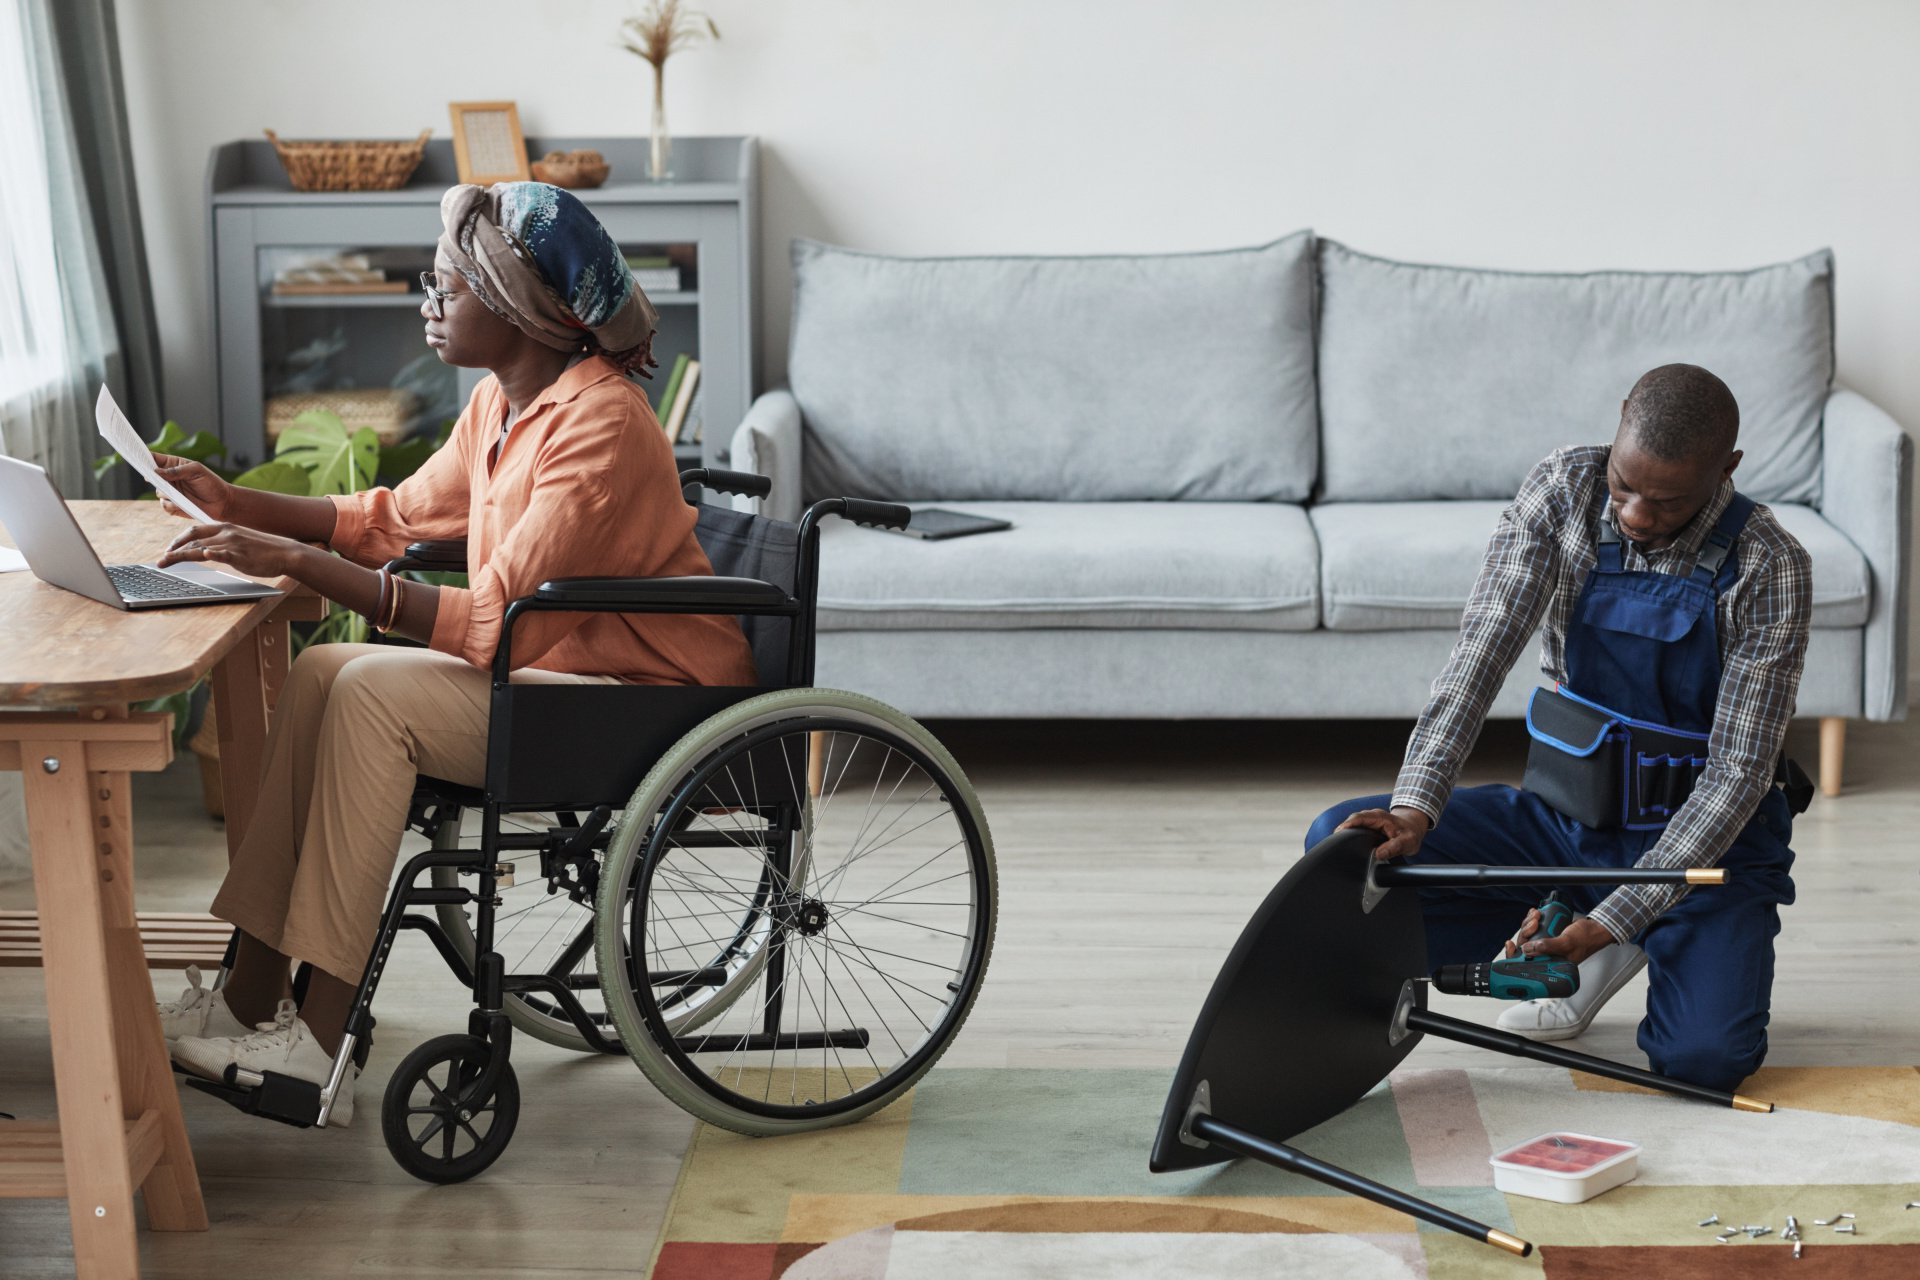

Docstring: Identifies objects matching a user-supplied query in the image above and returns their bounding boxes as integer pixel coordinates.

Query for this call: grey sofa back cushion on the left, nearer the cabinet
[787,232,1319,501]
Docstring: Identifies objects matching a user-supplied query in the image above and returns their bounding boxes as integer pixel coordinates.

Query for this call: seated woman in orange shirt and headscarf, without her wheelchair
[145,182,755,1125]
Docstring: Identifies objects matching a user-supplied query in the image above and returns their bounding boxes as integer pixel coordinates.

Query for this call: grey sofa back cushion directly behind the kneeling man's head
[1319,240,1834,503]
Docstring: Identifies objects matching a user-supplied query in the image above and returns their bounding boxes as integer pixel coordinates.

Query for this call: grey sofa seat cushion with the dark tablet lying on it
[818,503,1319,631]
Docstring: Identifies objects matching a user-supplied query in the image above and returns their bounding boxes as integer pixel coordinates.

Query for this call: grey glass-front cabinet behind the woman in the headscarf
[207,136,758,466]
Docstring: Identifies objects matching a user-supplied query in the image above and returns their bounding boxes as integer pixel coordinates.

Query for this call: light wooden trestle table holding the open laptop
[0,501,324,1278]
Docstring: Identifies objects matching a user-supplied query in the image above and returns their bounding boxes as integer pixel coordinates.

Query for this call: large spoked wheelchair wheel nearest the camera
[595,689,998,1134]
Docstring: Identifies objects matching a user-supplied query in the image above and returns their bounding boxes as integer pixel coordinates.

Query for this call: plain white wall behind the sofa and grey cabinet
[121,0,1920,679]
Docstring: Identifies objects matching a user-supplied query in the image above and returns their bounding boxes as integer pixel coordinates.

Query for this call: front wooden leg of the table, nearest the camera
[21,739,142,1276]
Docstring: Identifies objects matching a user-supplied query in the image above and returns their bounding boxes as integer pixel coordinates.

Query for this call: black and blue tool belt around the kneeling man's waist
[1521,689,1812,831]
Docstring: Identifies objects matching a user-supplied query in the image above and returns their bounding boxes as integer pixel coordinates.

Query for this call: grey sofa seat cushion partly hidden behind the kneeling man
[1309,503,1872,631]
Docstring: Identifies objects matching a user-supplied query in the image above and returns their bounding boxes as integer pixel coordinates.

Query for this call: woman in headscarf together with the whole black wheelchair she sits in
[139,182,996,1182]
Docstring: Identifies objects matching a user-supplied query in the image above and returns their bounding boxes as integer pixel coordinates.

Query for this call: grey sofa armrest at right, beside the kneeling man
[1820,388,1914,720]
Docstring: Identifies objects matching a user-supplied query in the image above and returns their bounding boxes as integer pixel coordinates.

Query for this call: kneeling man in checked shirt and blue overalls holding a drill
[1308,365,1812,1090]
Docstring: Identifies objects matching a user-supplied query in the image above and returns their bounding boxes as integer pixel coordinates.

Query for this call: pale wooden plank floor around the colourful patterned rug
[0,723,1920,1280]
